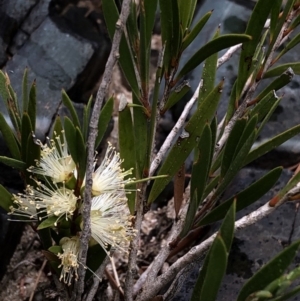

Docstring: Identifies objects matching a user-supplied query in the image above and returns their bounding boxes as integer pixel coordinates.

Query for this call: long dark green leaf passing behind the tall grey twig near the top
[101,0,140,97]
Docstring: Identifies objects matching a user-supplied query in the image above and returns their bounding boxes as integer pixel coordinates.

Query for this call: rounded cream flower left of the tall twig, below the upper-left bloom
[34,182,77,225]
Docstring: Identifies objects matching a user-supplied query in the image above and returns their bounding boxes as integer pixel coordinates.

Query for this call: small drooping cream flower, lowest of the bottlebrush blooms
[57,237,80,285]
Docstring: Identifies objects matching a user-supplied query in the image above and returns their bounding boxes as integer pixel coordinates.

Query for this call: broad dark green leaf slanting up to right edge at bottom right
[237,241,300,301]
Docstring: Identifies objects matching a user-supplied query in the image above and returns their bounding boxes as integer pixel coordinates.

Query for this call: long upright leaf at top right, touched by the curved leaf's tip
[236,0,275,98]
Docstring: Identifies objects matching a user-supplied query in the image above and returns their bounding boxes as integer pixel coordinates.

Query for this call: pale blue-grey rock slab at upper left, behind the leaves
[0,18,94,137]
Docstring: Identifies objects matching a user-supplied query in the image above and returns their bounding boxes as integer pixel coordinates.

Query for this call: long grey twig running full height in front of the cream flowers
[73,0,131,301]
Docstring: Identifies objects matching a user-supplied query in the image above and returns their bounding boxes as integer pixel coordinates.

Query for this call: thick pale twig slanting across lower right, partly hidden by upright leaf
[136,202,275,301]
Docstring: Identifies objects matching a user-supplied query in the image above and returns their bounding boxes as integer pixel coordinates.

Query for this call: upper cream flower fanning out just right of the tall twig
[92,143,133,196]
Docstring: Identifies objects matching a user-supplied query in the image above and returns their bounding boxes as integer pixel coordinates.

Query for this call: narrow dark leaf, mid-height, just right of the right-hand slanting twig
[221,118,247,178]
